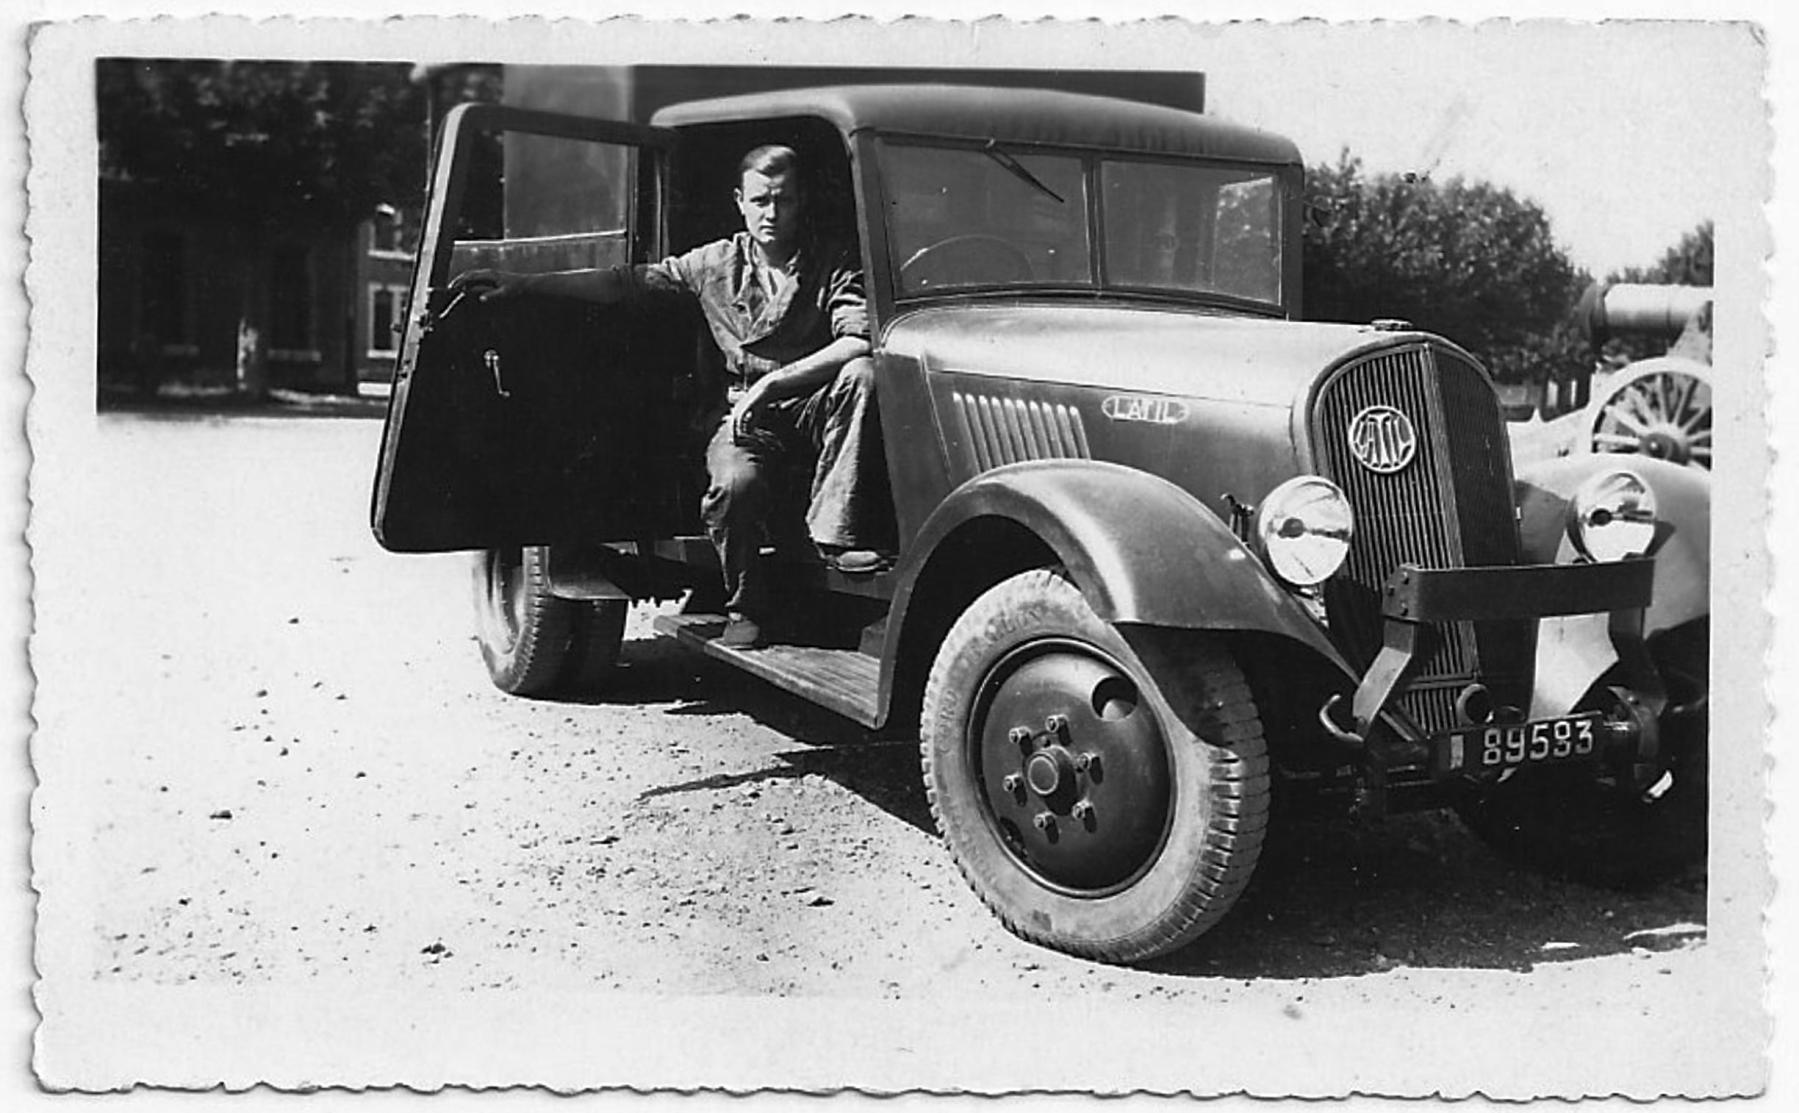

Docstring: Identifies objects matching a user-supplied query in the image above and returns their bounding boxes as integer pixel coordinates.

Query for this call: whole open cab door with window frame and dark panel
[372,104,700,552]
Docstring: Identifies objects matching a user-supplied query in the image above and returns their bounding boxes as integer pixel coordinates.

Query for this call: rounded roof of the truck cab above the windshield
[649,85,1299,165]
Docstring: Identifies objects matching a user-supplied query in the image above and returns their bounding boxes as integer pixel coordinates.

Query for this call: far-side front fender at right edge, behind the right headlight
[1515,453,1711,717]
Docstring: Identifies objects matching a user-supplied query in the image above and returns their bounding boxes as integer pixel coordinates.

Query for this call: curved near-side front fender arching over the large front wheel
[892,460,1355,676]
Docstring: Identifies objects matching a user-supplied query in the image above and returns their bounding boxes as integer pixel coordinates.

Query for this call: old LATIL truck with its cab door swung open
[372,65,1709,962]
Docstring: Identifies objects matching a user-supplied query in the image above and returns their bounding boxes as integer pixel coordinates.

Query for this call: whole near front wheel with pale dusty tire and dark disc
[919,570,1268,962]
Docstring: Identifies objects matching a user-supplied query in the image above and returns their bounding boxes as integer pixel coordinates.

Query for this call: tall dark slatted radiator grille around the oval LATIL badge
[1311,345,1535,732]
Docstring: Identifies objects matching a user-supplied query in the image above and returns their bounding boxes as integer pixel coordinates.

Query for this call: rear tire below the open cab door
[475,545,628,696]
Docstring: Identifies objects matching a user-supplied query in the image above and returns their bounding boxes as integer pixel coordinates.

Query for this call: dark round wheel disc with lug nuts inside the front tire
[970,642,1173,895]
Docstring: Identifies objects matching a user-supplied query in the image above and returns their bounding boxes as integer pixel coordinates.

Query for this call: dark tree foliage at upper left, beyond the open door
[95,58,426,223]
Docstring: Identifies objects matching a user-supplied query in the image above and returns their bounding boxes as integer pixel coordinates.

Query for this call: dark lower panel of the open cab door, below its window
[376,287,698,552]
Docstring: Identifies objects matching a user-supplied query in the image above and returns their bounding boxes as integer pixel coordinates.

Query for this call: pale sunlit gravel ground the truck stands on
[36,415,1755,1100]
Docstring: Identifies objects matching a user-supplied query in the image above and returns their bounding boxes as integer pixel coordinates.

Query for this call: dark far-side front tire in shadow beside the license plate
[1457,620,1711,890]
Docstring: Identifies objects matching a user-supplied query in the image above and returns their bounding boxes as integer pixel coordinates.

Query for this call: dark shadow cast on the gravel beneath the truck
[561,638,1705,978]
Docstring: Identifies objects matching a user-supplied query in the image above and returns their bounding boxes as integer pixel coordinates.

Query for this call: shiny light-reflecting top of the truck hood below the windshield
[882,302,1425,408]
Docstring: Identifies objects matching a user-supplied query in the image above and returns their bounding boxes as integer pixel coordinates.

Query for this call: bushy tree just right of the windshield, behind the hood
[1304,151,1587,381]
